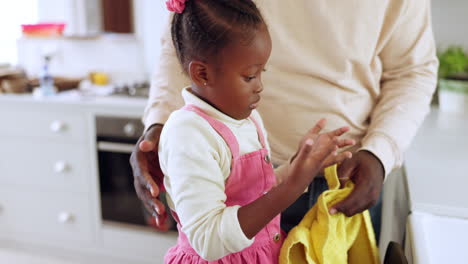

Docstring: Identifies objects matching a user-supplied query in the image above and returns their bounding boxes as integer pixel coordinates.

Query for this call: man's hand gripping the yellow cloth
[330,150,384,216]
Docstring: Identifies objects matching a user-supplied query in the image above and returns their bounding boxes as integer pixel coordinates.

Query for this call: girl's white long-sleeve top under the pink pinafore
[159,89,288,260]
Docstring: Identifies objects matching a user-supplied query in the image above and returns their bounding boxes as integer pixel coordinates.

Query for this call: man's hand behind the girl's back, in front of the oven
[130,124,167,230]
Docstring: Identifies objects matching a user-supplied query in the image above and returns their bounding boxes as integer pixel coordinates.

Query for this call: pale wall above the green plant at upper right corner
[432,0,468,50]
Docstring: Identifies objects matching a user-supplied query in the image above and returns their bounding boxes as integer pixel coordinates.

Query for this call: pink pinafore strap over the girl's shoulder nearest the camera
[182,105,239,160]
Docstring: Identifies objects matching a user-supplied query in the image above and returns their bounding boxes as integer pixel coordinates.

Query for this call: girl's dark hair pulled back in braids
[171,0,265,72]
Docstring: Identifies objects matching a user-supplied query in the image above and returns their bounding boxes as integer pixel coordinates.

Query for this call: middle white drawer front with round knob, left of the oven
[0,139,93,193]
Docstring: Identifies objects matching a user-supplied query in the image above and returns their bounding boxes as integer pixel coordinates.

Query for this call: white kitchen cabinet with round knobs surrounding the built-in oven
[0,95,177,264]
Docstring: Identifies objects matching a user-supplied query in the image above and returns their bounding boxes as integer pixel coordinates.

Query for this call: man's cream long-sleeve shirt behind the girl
[143,0,438,177]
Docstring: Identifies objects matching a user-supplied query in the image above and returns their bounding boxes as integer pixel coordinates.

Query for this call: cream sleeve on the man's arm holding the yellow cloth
[361,0,438,175]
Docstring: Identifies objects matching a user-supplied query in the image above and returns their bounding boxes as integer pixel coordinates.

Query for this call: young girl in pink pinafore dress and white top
[159,0,354,264]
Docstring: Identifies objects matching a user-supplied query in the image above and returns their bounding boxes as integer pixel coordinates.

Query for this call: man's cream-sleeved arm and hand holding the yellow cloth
[330,0,438,216]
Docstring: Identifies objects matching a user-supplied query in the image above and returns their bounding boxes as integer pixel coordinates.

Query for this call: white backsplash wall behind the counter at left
[18,34,147,81]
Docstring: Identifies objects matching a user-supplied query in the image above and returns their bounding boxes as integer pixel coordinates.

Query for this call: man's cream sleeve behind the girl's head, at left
[143,14,190,129]
